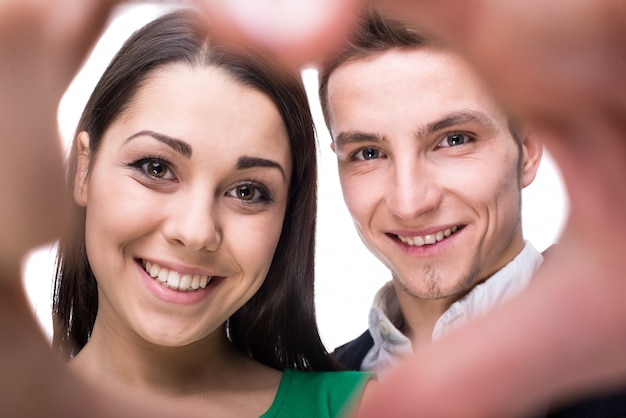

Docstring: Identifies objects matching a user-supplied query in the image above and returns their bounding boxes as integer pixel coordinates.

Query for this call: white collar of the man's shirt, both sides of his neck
[361,241,543,375]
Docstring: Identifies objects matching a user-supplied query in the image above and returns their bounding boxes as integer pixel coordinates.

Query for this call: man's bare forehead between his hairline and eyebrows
[327,47,502,118]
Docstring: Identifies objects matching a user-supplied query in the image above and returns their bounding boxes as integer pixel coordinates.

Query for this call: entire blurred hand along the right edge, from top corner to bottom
[201,0,626,417]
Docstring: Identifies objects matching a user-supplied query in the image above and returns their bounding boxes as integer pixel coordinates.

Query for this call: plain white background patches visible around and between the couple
[24,4,567,349]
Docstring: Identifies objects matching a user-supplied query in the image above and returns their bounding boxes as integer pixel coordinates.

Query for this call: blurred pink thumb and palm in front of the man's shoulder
[358,118,626,418]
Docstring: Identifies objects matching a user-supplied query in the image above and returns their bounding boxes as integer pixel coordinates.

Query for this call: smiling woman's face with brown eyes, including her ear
[74,64,292,346]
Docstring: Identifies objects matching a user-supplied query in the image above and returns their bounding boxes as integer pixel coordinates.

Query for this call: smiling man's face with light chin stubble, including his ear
[328,49,541,299]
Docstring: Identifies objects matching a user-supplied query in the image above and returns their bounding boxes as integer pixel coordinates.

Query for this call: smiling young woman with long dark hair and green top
[53,10,368,417]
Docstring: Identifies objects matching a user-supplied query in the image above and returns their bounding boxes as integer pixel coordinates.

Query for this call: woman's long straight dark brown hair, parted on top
[53,10,335,370]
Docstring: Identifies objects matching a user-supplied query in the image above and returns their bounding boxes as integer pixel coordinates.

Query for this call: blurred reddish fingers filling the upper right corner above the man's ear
[377,0,626,123]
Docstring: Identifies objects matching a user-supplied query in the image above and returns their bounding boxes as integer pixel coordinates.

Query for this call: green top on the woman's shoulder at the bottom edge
[261,369,374,418]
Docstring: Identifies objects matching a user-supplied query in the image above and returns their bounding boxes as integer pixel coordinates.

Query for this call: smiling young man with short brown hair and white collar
[320,11,543,373]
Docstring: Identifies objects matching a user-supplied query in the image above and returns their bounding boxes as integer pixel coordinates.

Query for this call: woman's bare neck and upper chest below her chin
[69,321,282,416]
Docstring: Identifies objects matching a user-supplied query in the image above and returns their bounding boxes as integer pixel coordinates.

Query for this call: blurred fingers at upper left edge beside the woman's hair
[0,0,115,274]
